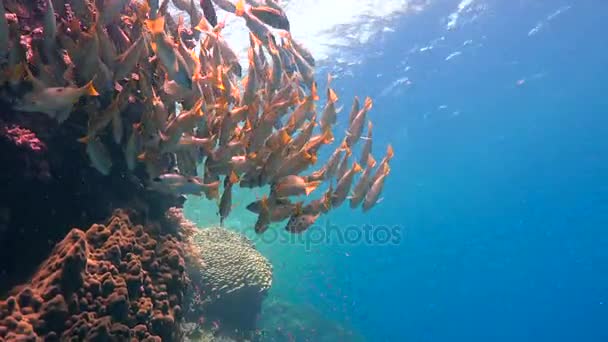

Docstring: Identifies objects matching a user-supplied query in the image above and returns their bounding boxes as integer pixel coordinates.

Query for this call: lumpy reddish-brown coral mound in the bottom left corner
[0,211,188,341]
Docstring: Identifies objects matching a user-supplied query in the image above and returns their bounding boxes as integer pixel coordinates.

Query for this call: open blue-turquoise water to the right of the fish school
[186,0,608,341]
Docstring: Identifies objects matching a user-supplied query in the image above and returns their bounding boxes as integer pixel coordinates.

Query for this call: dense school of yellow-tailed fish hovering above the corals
[0,0,393,234]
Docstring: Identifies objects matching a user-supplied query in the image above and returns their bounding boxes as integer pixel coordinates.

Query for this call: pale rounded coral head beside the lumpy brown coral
[188,227,272,337]
